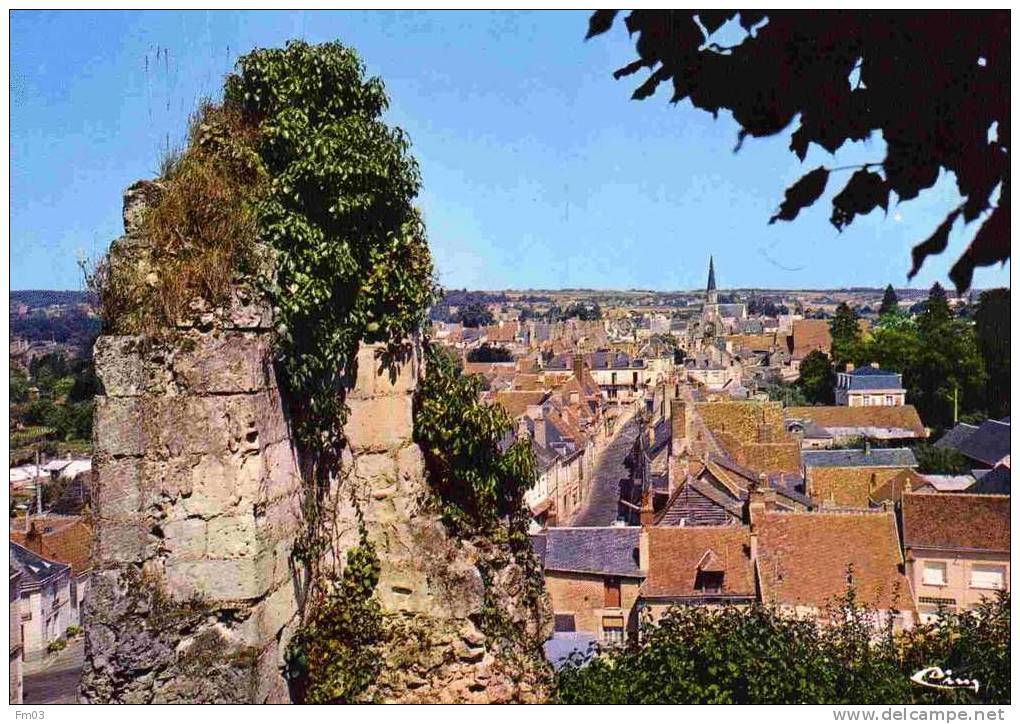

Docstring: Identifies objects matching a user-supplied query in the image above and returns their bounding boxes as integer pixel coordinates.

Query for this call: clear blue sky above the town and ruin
[10,11,1010,291]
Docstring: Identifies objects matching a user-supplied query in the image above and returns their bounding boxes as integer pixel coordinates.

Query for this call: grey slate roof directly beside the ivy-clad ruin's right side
[545,526,644,577]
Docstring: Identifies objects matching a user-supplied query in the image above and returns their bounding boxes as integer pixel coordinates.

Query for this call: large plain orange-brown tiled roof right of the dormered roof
[758,512,914,611]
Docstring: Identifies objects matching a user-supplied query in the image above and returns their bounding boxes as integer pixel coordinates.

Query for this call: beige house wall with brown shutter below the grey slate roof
[546,570,641,637]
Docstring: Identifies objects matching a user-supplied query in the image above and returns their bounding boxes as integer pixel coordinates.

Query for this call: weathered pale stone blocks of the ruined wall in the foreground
[82,185,551,703]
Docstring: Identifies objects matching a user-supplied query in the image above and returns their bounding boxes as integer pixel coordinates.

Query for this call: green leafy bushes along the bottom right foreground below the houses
[557,588,1010,705]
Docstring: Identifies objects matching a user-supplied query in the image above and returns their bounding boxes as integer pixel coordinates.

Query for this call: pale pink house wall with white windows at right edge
[907,549,1010,620]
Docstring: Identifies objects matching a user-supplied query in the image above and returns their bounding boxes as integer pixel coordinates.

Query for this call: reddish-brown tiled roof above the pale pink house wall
[903,493,1010,552]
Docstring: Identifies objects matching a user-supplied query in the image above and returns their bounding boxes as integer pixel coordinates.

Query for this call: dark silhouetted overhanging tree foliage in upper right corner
[587,10,1010,291]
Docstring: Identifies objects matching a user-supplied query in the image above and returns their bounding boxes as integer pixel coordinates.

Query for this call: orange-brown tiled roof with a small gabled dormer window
[641,525,755,599]
